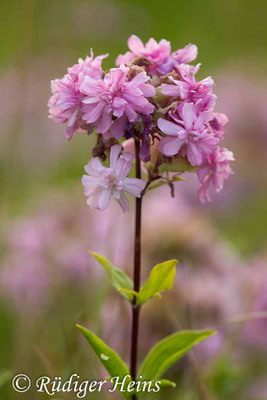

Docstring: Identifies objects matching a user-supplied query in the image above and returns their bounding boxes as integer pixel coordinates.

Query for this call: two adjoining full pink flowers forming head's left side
[48,52,156,139]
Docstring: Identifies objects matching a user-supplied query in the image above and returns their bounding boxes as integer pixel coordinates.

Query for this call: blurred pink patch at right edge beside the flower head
[216,67,267,191]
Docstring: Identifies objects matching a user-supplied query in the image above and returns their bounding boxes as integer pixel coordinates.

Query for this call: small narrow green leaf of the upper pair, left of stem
[89,251,133,301]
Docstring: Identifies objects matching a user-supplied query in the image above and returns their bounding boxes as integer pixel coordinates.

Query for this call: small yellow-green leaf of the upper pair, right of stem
[137,260,178,305]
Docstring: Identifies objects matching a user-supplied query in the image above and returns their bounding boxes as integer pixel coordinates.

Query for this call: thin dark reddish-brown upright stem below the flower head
[130,139,142,400]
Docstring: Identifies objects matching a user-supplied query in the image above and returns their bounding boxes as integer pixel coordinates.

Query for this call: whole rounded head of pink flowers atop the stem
[48,35,234,211]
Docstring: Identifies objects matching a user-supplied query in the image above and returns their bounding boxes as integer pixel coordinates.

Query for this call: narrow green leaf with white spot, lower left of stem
[76,325,132,397]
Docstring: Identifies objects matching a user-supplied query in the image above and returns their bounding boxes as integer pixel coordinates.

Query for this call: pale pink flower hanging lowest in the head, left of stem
[82,145,146,212]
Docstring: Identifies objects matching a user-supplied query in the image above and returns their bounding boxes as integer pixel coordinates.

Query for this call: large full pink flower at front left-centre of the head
[81,66,155,139]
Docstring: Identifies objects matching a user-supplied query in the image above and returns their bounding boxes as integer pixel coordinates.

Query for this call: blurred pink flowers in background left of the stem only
[0,196,133,313]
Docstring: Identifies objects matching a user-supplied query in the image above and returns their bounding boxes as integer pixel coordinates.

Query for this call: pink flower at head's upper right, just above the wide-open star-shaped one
[161,64,214,102]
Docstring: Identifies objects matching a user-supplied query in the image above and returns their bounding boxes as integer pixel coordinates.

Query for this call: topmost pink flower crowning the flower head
[116,35,175,75]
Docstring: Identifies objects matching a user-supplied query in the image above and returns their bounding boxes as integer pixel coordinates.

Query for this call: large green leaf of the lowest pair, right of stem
[138,330,217,380]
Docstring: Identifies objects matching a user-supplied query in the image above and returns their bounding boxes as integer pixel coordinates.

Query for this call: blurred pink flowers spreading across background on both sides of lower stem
[0,185,267,376]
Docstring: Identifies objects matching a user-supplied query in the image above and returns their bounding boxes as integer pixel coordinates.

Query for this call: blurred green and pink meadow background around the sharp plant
[0,0,267,400]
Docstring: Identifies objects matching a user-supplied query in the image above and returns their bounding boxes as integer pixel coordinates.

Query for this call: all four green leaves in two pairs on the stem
[77,252,216,399]
